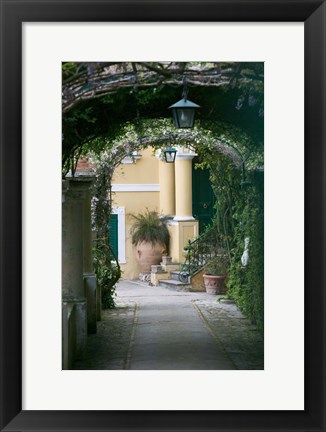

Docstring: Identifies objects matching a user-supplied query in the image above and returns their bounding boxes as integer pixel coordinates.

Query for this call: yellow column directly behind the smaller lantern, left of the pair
[159,160,175,216]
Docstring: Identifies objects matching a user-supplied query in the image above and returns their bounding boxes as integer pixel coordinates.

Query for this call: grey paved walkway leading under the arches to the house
[75,281,264,370]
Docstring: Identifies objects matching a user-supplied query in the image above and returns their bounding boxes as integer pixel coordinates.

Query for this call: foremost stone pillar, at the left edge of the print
[62,180,87,359]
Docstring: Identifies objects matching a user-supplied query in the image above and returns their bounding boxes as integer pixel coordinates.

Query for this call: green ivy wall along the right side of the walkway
[197,147,264,332]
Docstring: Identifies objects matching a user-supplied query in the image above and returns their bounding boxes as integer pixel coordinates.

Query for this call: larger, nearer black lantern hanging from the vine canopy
[169,77,200,129]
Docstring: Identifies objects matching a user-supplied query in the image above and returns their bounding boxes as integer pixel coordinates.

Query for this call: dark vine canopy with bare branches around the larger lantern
[62,62,264,172]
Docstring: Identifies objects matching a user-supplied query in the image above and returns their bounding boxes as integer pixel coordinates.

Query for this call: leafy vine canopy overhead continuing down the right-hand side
[62,63,263,328]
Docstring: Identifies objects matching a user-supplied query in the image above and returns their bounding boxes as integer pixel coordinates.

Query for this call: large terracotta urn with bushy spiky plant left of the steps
[131,209,170,273]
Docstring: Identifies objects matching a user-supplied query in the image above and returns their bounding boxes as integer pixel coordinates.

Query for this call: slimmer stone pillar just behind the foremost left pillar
[70,175,97,333]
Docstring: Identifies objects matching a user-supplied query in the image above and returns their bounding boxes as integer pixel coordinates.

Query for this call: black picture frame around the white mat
[0,0,326,432]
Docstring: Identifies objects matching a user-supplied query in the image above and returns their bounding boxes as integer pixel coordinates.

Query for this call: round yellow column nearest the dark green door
[174,153,195,221]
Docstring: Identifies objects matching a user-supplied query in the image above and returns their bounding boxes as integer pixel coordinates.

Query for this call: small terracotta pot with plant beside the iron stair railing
[203,256,228,294]
